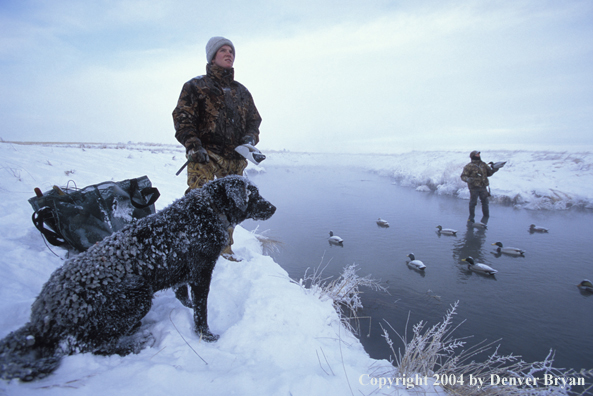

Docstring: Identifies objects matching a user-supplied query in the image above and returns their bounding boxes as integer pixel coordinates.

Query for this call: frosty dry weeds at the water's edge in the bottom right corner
[379,302,593,396]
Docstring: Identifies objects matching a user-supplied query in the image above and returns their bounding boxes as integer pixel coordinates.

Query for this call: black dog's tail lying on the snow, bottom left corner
[0,324,63,381]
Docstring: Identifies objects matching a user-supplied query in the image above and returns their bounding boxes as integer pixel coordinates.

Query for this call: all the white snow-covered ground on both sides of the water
[0,143,593,396]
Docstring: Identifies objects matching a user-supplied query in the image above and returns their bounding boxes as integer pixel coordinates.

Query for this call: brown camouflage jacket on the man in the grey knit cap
[173,64,261,159]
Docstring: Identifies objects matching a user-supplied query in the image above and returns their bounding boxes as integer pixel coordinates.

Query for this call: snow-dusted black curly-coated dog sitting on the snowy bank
[0,176,276,381]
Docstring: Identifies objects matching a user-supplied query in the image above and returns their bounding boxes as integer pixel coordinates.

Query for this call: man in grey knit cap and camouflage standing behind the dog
[173,37,261,261]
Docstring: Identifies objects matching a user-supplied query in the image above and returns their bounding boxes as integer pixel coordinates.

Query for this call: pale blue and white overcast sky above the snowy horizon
[0,0,593,153]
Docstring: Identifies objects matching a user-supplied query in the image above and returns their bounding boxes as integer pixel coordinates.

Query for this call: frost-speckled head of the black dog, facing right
[203,176,276,224]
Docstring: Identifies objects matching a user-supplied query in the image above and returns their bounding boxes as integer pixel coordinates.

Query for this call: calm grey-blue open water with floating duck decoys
[243,163,593,369]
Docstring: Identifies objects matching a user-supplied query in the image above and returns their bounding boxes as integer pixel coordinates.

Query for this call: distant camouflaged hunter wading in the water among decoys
[461,150,498,223]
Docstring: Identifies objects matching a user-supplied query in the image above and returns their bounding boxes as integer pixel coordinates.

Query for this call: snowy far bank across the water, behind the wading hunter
[262,150,593,210]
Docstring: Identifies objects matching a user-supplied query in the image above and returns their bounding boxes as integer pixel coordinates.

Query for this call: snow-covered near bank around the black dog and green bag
[0,144,444,396]
